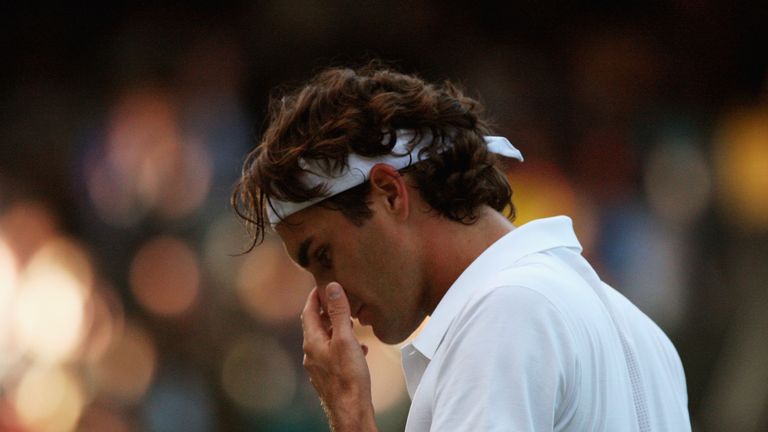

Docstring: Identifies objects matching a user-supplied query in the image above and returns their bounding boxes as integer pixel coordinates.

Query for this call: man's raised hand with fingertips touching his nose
[301,282,377,432]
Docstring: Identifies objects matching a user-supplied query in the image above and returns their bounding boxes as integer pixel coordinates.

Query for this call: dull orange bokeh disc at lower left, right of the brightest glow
[90,322,157,404]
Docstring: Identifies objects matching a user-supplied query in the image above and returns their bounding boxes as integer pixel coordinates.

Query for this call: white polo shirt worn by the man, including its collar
[402,216,691,432]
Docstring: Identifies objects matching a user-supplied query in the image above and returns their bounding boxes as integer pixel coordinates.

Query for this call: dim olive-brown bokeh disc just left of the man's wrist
[221,334,297,413]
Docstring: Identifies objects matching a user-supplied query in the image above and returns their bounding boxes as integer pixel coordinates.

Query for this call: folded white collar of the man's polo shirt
[406,216,582,360]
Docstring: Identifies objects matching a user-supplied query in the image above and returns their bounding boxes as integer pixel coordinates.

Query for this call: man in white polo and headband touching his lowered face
[233,65,690,432]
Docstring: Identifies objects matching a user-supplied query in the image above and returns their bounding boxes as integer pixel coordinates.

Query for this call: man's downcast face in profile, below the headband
[277,205,426,344]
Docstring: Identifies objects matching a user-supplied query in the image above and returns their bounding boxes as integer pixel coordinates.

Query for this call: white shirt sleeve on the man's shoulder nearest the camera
[431,286,577,432]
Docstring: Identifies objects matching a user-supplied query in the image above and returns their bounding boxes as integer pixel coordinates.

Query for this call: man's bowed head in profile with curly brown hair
[233,65,513,343]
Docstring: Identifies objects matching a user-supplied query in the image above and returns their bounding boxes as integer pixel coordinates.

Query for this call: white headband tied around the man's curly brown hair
[267,129,523,226]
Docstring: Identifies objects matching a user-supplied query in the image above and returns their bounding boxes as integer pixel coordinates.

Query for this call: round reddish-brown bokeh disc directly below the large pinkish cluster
[130,236,200,316]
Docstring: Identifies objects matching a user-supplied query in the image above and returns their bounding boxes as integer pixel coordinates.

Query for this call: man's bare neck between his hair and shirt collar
[414,207,515,315]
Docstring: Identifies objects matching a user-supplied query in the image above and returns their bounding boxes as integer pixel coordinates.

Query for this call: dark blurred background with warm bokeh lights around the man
[0,0,768,432]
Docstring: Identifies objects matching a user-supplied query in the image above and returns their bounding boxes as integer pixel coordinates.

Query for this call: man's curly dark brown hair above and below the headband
[231,63,514,248]
